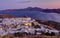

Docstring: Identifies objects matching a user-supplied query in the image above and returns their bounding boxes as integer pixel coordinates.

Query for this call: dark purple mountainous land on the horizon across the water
[2,7,60,13]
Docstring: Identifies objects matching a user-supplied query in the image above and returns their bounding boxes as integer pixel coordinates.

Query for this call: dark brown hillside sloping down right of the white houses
[36,20,60,31]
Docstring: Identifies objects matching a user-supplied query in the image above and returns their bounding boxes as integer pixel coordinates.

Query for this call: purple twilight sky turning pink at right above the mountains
[0,0,60,10]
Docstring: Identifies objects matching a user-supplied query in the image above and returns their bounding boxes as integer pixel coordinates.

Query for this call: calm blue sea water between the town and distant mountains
[0,11,60,22]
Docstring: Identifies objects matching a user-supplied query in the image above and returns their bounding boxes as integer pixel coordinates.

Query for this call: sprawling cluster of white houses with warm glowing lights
[0,17,59,35]
